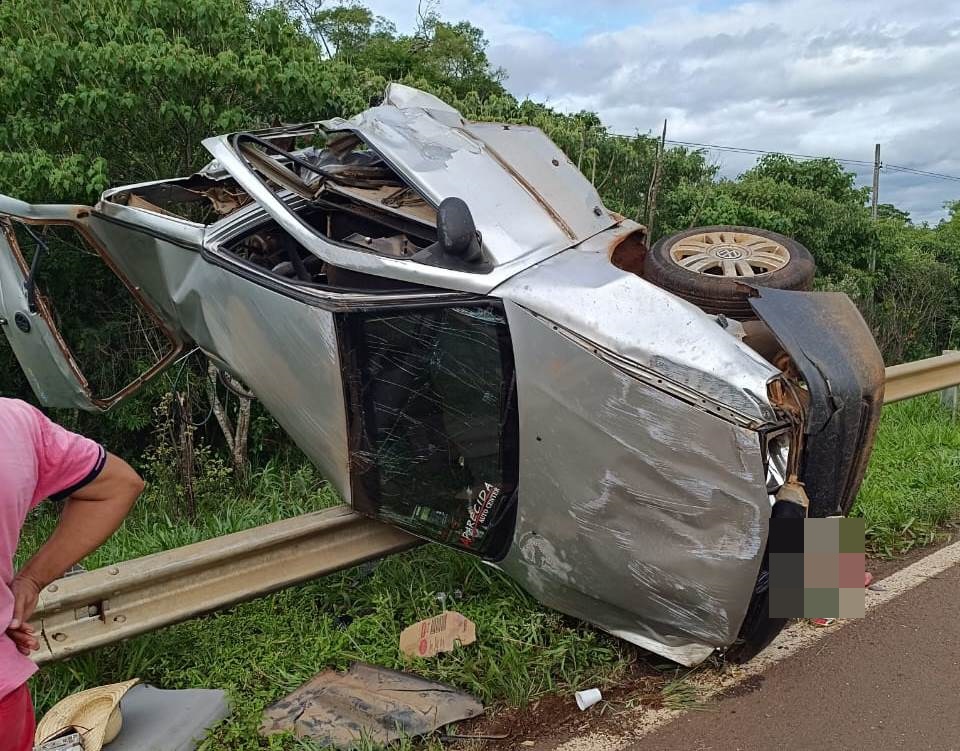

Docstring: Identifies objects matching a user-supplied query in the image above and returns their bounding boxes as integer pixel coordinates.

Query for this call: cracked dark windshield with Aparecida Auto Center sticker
[342,304,517,558]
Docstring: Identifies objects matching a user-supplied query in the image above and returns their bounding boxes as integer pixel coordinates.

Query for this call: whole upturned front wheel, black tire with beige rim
[643,225,816,320]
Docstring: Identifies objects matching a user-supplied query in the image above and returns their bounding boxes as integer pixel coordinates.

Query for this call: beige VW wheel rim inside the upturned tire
[670,231,790,277]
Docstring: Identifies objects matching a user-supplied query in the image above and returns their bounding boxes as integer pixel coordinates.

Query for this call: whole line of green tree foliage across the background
[0,0,960,458]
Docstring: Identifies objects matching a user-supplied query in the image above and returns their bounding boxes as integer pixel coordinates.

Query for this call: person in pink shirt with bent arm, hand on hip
[0,398,143,751]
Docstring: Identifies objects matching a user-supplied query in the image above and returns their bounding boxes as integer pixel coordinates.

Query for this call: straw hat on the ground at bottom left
[34,678,140,751]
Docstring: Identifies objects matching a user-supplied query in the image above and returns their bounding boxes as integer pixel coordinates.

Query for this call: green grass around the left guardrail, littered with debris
[21,458,634,751]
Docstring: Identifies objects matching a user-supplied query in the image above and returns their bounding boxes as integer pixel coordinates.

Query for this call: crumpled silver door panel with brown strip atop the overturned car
[321,83,620,266]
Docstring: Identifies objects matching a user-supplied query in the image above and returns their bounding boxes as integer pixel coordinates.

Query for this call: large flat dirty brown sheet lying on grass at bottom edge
[260,662,483,751]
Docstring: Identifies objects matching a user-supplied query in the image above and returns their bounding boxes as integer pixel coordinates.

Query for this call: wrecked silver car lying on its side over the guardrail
[0,84,883,665]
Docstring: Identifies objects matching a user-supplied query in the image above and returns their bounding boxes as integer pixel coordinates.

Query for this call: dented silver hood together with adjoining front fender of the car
[488,239,783,664]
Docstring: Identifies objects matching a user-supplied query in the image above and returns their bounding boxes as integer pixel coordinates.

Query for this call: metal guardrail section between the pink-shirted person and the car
[31,506,421,663]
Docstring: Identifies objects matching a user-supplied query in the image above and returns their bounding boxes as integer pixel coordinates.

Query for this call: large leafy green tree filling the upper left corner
[0,0,384,202]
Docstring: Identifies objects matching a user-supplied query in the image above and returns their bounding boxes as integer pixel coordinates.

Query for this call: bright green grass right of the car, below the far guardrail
[853,395,960,557]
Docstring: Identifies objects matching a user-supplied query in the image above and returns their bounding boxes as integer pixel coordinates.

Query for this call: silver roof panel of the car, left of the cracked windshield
[79,207,350,503]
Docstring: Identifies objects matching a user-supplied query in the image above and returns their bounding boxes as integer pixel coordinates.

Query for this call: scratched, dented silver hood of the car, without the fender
[500,304,770,665]
